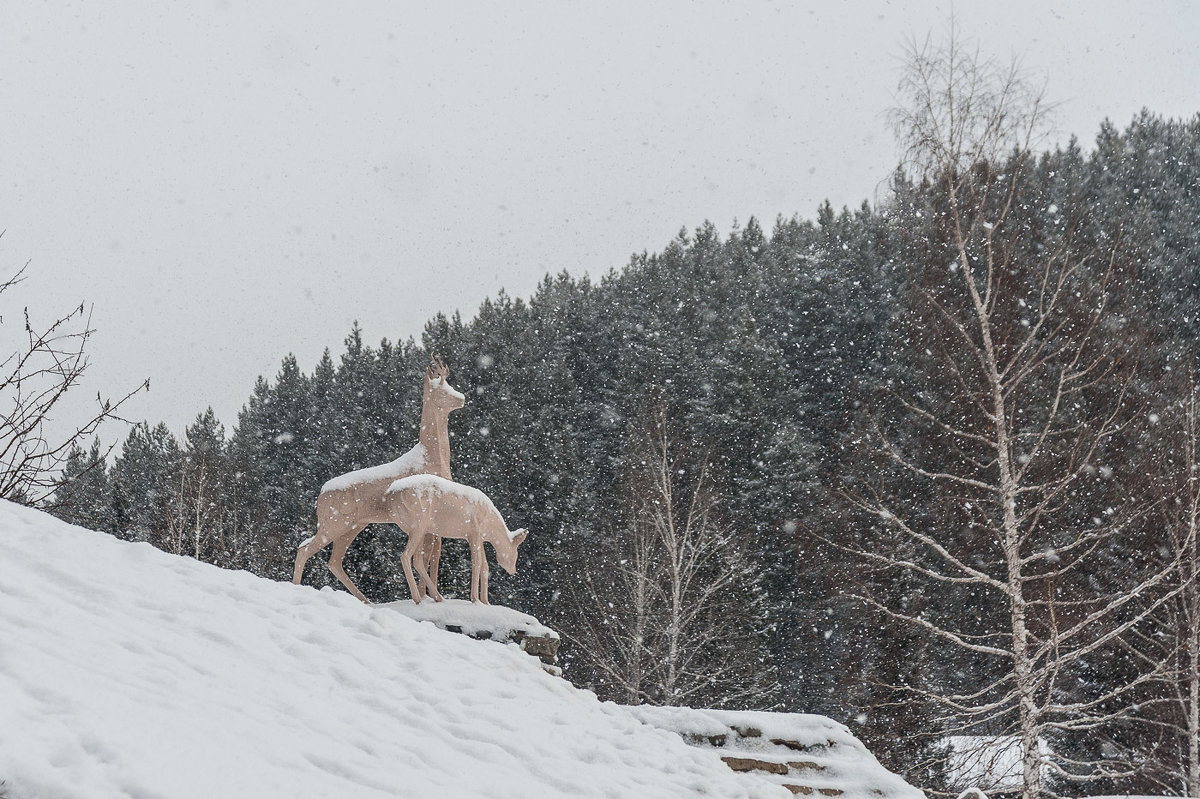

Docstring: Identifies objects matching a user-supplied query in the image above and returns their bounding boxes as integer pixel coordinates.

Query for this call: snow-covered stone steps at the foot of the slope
[630,705,925,799]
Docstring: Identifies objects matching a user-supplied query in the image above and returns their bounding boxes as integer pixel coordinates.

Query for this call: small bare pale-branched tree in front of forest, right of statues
[576,405,779,707]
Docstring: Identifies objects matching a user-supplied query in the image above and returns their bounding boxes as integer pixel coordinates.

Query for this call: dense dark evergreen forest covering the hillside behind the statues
[51,113,1200,793]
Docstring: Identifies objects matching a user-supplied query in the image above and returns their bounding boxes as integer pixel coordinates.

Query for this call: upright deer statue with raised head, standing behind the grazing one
[292,358,466,602]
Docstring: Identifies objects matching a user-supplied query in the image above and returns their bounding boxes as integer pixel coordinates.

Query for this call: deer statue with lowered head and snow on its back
[384,474,529,605]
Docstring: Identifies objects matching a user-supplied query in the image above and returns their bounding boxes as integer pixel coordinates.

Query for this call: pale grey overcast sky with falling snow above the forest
[0,0,1200,437]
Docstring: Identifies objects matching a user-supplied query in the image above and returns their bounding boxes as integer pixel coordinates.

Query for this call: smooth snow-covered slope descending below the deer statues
[0,501,791,799]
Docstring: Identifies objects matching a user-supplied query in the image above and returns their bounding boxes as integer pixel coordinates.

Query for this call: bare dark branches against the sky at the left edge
[0,257,150,505]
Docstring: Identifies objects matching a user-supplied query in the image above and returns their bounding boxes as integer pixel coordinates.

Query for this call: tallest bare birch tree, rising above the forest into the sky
[847,35,1172,799]
